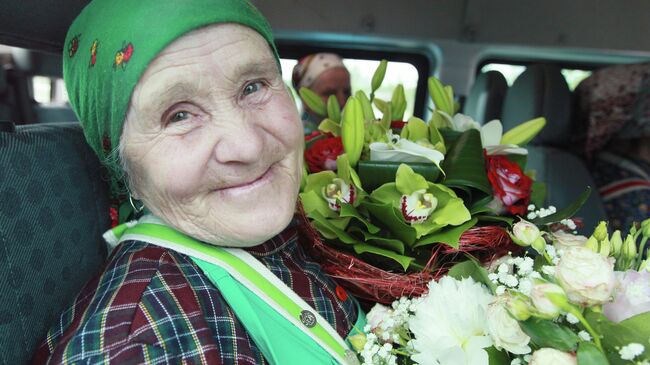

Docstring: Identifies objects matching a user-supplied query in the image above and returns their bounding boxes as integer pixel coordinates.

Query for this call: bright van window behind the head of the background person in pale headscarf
[280,58,419,120]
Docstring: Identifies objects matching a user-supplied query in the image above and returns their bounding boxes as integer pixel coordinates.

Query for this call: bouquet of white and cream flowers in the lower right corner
[352,219,650,365]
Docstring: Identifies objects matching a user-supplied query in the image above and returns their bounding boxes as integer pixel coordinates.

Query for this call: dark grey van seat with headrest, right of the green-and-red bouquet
[502,65,606,232]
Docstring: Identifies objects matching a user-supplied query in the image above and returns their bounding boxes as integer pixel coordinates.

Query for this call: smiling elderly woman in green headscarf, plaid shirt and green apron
[33,0,364,364]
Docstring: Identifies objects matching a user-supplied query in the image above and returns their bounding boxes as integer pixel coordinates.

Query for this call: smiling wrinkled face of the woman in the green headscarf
[121,24,303,246]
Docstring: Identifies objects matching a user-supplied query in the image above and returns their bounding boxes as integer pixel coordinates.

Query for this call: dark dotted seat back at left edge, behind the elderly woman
[0,123,110,364]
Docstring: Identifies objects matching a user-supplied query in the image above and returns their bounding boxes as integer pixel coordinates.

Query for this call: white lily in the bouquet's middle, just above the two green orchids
[369,131,445,165]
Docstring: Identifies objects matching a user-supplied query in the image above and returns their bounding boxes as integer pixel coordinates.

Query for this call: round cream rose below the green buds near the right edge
[556,247,616,306]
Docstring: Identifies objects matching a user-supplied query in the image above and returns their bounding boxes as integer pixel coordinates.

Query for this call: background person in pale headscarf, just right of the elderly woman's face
[291,53,352,134]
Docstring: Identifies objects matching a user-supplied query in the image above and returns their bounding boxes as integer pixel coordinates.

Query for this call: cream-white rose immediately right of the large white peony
[487,297,530,355]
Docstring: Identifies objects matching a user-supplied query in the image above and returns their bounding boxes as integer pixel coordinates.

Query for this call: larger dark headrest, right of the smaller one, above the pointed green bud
[501,64,571,146]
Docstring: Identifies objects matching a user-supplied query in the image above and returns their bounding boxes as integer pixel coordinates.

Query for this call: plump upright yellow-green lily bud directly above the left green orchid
[341,96,365,167]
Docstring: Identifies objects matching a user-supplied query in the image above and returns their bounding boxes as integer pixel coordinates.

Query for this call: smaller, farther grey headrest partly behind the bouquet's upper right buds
[463,71,508,125]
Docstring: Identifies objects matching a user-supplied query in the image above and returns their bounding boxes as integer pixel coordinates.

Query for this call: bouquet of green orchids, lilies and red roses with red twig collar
[300,61,589,303]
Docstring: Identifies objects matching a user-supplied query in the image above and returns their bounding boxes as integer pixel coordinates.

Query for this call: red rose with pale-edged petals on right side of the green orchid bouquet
[486,155,533,215]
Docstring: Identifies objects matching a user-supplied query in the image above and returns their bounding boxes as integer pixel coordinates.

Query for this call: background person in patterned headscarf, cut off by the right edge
[576,63,650,232]
